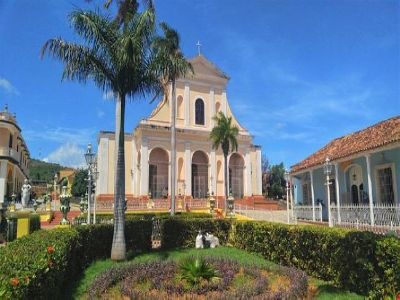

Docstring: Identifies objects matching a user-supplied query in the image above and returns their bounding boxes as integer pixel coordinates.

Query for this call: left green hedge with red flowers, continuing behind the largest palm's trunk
[0,220,152,299]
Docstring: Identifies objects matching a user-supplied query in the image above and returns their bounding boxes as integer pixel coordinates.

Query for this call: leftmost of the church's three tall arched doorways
[149,148,169,199]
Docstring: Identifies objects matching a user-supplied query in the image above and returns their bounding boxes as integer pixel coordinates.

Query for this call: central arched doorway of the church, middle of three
[192,151,208,199]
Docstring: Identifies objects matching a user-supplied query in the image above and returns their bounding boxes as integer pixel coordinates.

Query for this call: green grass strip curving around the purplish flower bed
[68,247,363,300]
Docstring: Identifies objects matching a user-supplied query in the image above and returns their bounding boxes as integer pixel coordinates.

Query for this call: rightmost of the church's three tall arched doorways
[229,153,244,199]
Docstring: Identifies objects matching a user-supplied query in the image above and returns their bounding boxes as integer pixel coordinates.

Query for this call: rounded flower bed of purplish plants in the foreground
[88,258,307,299]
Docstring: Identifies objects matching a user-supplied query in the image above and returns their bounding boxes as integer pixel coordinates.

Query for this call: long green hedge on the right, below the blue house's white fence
[231,221,400,298]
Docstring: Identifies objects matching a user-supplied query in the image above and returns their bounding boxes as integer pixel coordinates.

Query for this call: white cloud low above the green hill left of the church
[43,143,85,168]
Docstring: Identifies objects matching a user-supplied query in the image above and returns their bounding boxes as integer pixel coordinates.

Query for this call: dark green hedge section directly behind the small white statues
[161,218,232,249]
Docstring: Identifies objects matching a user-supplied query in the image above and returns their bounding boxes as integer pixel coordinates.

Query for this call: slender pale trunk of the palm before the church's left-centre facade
[170,80,176,216]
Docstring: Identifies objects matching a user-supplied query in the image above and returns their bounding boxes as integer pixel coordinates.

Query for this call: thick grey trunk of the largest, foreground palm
[111,94,126,261]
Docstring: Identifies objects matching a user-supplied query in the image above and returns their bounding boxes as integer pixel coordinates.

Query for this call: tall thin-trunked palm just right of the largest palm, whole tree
[153,23,193,215]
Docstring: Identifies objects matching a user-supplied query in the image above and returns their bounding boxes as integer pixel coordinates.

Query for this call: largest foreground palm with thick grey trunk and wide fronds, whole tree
[42,6,160,260]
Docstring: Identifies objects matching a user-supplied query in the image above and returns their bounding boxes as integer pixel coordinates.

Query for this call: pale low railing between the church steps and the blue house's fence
[235,204,290,223]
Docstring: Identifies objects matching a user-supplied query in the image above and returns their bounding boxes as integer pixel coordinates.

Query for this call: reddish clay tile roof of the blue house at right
[291,116,400,172]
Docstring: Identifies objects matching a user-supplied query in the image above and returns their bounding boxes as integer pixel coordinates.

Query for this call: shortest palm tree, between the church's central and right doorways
[210,112,239,210]
